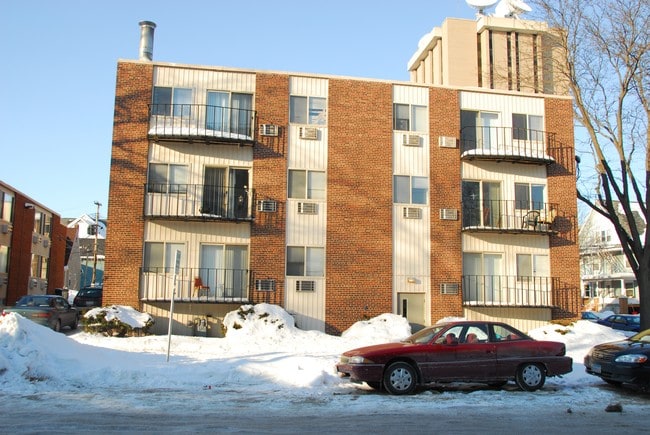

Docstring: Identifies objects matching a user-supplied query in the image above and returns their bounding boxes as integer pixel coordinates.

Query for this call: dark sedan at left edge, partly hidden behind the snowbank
[2,295,79,332]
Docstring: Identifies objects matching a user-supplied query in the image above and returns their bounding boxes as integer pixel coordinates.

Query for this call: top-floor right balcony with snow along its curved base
[460,126,555,165]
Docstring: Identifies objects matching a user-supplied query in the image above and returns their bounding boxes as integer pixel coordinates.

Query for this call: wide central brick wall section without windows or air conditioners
[325,79,393,334]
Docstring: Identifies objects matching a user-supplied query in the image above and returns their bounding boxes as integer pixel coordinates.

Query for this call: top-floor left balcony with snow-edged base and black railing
[149,104,255,146]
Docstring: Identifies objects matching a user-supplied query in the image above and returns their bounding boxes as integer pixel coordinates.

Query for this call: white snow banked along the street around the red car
[0,304,647,418]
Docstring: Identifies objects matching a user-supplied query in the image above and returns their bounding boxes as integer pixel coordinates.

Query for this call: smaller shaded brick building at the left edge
[0,181,68,306]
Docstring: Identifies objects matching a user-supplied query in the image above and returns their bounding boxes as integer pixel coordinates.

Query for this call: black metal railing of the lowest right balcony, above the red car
[463,275,552,307]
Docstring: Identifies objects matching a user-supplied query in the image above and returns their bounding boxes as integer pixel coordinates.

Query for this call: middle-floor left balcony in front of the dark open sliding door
[144,184,254,222]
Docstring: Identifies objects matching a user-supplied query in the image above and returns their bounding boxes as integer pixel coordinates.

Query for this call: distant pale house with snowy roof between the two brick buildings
[63,214,106,290]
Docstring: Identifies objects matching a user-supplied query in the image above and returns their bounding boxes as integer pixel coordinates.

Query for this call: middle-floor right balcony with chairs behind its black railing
[462,200,558,235]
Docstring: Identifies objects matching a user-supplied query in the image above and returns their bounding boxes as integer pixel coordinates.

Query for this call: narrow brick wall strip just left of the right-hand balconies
[429,88,463,323]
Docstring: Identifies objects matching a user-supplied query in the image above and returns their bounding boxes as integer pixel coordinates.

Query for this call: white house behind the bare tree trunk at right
[578,204,646,311]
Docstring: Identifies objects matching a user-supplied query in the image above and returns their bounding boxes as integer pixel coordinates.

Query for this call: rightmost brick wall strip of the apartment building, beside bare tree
[545,98,582,318]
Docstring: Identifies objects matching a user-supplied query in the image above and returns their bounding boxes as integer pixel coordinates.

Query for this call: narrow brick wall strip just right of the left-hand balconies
[250,73,289,306]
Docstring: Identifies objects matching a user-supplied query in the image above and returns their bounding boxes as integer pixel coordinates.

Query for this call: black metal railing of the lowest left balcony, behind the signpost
[140,267,250,303]
